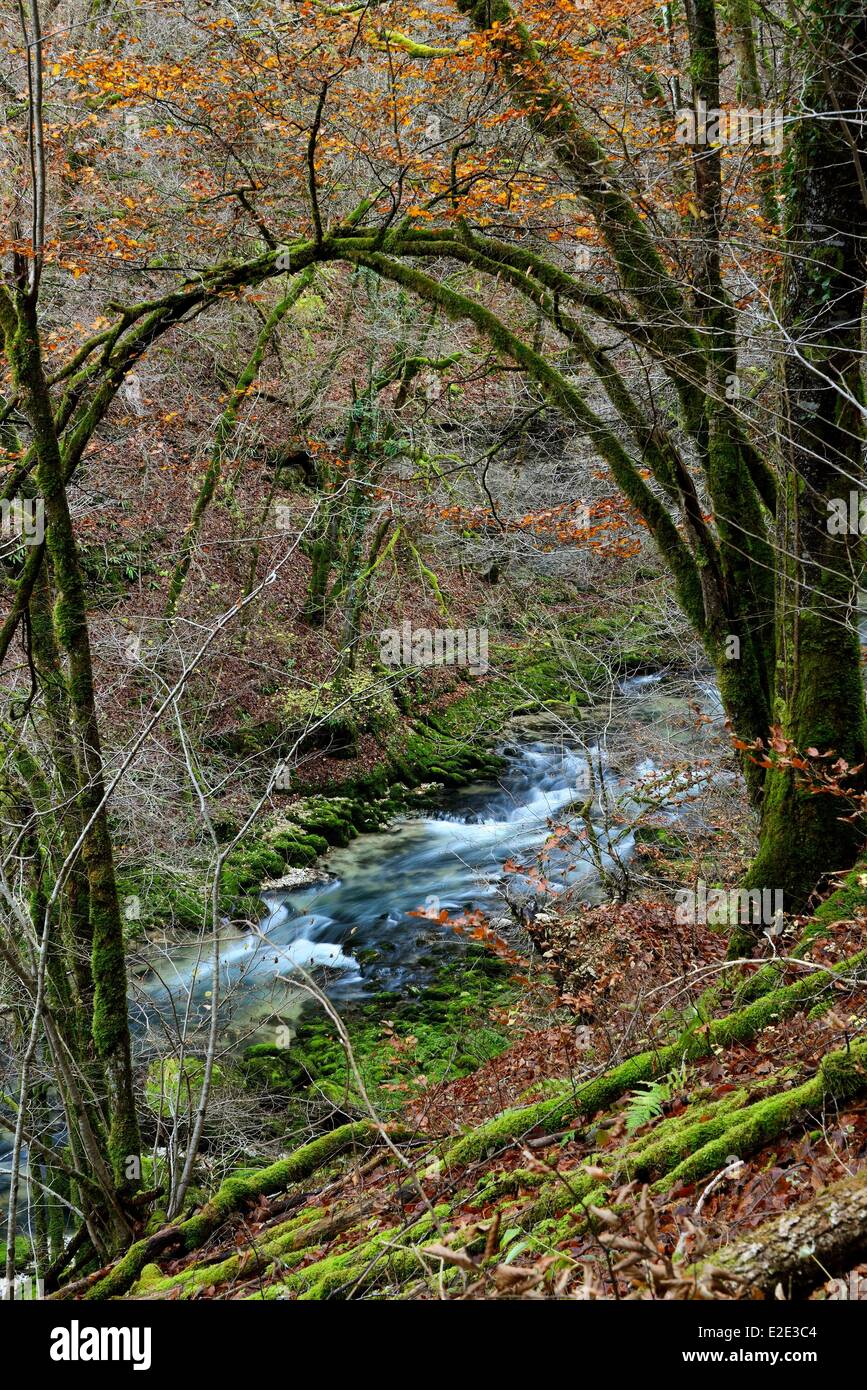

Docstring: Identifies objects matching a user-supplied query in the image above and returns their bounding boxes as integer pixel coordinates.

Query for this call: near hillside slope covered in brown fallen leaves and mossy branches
[52,845,867,1300]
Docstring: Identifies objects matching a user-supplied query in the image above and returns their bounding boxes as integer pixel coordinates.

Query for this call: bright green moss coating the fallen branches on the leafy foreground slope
[83,962,867,1301]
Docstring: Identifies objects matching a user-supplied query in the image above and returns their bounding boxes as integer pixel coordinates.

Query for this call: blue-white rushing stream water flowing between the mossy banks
[134,676,716,1041]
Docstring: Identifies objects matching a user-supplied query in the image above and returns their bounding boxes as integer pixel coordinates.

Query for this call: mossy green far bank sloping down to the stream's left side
[118,606,682,947]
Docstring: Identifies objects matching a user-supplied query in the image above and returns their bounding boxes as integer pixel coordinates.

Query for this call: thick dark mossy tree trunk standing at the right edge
[750,0,867,909]
